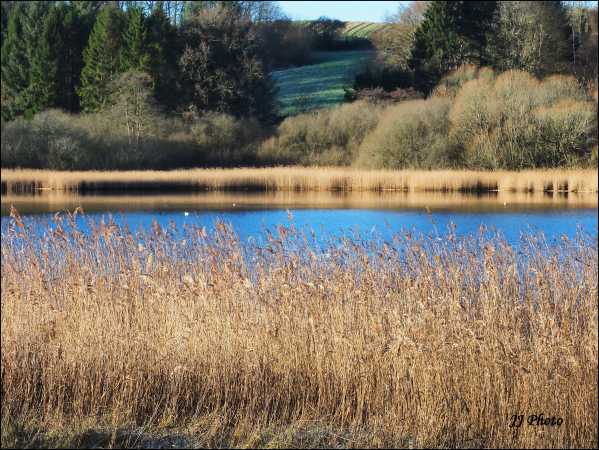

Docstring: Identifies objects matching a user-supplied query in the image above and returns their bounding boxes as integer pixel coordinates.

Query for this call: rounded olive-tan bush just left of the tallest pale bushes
[357,98,451,169]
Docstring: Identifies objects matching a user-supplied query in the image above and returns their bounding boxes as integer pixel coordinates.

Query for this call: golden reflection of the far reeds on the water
[1,190,597,215]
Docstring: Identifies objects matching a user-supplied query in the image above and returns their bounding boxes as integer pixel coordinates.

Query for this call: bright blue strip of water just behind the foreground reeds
[1,208,598,246]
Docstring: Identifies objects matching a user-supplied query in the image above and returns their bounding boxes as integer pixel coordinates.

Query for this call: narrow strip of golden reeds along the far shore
[2,167,598,193]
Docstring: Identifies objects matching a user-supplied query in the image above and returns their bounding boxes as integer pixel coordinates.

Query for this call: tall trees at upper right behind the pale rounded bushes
[356,1,597,92]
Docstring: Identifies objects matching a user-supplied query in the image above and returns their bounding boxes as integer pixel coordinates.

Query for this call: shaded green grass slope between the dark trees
[273,50,374,116]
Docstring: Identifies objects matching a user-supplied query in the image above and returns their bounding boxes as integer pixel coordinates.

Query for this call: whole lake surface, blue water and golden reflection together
[1,191,597,246]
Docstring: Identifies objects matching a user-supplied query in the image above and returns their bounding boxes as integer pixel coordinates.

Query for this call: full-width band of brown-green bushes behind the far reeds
[0,66,597,170]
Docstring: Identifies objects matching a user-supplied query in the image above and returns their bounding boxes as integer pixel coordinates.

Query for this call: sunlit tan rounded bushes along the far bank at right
[268,65,597,170]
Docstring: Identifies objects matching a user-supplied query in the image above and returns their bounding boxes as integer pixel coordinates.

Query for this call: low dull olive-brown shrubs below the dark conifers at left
[1,110,261,170]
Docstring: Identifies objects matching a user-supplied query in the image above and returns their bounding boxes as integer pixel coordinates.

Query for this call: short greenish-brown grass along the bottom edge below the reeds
[2,415,413,448]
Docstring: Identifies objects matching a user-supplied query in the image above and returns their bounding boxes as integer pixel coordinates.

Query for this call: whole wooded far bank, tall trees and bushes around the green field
[1,1,597,170]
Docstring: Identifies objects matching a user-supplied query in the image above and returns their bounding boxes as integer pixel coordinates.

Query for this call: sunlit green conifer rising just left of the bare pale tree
[78,7,125,112]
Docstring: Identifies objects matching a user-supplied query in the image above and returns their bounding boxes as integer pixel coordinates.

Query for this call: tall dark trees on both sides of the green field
[1,1,597,120]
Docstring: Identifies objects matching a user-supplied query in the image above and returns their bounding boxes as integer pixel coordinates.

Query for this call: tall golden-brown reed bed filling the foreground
[1,210,598,448]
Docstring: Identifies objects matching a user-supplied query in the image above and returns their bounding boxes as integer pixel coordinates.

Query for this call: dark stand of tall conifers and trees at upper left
[2,1,281,120]
